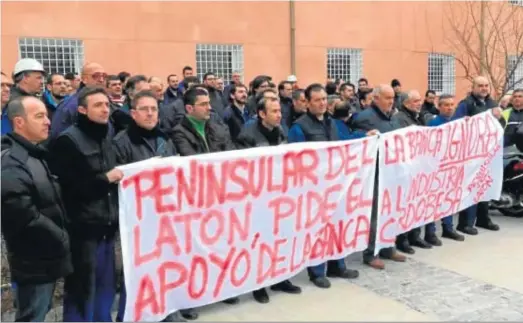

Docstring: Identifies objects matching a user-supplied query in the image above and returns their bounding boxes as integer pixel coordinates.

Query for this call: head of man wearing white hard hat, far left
[11,58,45,100]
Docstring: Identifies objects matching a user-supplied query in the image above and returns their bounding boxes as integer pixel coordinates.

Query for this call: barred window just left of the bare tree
[429,53,456,95]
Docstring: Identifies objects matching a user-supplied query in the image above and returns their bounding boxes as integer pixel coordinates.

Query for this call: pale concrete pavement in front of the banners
[2,216,523,321]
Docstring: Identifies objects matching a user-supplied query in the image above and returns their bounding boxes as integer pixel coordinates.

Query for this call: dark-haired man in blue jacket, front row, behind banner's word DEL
[288,83,359,288]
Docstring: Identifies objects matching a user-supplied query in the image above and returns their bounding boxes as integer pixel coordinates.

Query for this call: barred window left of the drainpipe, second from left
[196,44,243,82]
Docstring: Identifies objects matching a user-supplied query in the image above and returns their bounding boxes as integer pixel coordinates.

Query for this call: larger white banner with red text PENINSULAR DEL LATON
[119,137,378,321]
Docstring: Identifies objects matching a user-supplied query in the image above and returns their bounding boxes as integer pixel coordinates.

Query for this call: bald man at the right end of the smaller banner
[453,76,505,235]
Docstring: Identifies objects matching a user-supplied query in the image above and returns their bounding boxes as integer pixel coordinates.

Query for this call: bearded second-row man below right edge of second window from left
[223,84,254,141]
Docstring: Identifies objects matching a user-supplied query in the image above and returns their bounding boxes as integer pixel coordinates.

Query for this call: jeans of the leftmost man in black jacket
[14,282,56,322]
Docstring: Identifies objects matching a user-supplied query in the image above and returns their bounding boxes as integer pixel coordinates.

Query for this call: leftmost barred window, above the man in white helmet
[18,38,84,74]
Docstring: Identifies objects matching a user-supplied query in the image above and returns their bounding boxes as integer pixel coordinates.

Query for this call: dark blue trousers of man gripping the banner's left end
[64,236,116,322]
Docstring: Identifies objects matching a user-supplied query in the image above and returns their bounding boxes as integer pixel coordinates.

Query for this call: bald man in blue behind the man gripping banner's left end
[51,63,107,138]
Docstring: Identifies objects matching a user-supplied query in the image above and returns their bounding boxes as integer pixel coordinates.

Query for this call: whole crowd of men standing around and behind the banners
[1,59,523,322]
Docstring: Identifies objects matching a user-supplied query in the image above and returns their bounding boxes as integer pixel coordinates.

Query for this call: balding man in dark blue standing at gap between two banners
[352,84,406,269]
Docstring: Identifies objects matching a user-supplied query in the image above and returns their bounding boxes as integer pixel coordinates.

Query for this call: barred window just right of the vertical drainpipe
[327,48,363,84]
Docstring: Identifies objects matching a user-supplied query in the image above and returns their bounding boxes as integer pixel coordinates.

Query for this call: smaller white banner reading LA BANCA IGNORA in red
[376,111,503,252]
